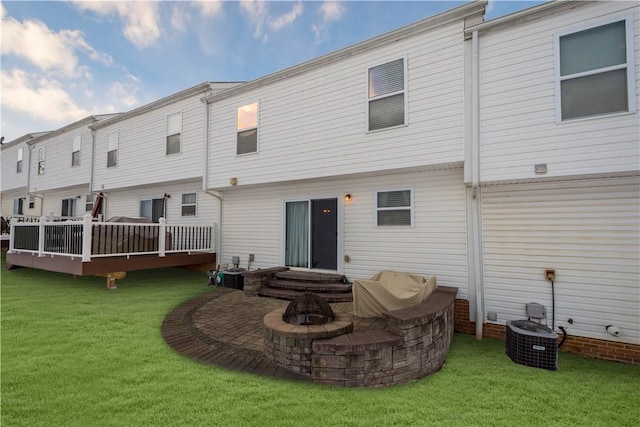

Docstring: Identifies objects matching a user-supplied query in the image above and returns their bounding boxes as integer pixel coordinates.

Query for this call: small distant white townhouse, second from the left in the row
[26,114,119,217]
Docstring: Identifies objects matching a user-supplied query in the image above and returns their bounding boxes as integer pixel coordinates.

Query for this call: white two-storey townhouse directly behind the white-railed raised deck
[91,82,237,224]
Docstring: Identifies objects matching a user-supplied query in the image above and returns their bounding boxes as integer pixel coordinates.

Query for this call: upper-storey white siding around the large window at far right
[480,2,640,181]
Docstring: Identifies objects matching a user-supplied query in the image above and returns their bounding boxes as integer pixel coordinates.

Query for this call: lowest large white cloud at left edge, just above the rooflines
[0,69,89,123]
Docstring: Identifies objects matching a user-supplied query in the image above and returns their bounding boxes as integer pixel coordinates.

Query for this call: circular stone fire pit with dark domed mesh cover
[263,295,353,375]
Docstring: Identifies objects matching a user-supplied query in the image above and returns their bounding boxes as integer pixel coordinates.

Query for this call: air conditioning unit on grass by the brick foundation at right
[506,320,558,371]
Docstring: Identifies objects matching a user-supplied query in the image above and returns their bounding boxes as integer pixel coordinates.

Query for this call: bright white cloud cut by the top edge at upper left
[75,1,160,48]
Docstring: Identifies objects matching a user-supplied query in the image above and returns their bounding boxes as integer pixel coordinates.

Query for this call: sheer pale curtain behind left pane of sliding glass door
[285,201,309,267]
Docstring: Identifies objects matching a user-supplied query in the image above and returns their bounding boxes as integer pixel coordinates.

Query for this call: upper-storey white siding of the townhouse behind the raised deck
[94,94,205,191]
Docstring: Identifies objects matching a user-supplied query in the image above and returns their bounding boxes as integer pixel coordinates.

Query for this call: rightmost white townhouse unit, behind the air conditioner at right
[465,2,640,354]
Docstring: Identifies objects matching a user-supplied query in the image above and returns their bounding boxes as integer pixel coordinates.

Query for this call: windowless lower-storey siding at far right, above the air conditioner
[482,177,640,344]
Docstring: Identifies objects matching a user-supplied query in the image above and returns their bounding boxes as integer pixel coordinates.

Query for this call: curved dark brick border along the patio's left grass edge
[161,288,311,381]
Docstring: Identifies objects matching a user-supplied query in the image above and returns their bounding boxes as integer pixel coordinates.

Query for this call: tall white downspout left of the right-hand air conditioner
[471,30,484,340]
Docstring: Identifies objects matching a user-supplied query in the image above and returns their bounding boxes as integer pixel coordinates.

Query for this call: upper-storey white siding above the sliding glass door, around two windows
[209,23,464,188]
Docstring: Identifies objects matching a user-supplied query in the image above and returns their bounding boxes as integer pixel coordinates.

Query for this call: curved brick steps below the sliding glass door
[258,270,353,302]
